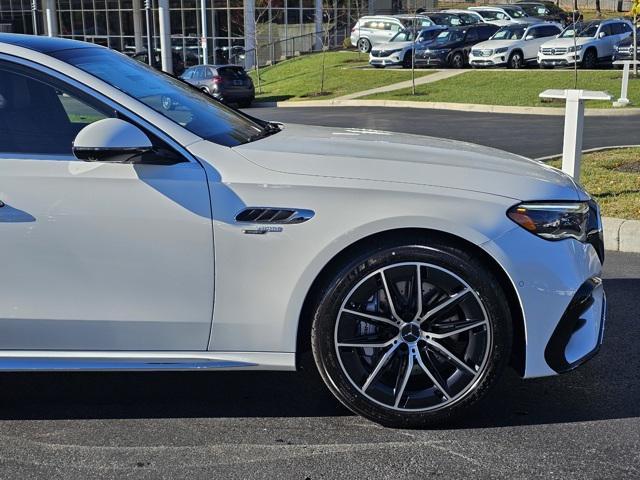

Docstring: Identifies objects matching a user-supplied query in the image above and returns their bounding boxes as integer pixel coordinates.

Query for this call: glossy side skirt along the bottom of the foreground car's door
[0,350,295,372]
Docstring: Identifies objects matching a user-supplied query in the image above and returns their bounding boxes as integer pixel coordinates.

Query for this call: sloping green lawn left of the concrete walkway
[250,51,433,101]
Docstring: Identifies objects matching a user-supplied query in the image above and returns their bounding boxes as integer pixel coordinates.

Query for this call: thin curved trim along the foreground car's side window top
[0,53,202,166]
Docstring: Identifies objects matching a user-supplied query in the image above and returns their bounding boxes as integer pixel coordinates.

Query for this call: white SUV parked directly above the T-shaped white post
[538,19,633,68]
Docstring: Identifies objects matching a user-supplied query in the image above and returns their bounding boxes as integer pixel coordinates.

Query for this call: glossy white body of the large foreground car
[0,36,601,376]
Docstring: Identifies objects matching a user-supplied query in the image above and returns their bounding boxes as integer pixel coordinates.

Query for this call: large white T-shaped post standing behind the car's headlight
[539,90,611,181]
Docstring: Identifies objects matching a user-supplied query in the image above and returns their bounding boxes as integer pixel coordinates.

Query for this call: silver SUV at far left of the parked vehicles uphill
[351,15,433,53]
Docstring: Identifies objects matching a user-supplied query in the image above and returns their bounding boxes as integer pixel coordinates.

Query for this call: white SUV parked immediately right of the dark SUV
[469,23,562,68]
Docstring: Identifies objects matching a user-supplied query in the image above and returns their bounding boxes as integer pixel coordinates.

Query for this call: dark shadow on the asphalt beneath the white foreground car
[0,279,640,428]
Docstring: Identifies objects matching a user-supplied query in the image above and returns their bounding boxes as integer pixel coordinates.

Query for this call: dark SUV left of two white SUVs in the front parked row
[415,23,500,68]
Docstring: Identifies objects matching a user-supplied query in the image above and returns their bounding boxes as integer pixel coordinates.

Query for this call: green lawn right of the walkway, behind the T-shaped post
[365,70,640,108]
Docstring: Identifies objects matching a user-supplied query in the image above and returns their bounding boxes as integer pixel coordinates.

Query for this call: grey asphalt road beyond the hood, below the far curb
[247,107,640,158]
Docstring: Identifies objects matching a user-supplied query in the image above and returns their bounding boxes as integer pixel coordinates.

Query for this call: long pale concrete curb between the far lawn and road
[253,98,640,117]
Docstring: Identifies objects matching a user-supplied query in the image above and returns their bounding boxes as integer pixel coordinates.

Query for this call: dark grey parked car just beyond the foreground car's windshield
[180,65,256,107]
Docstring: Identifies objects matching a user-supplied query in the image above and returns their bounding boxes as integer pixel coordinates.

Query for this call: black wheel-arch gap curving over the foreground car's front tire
[296,228,526,376]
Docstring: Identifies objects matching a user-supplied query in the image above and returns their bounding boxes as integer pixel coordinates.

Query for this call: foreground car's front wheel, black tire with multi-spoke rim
[311,238,512,428]
